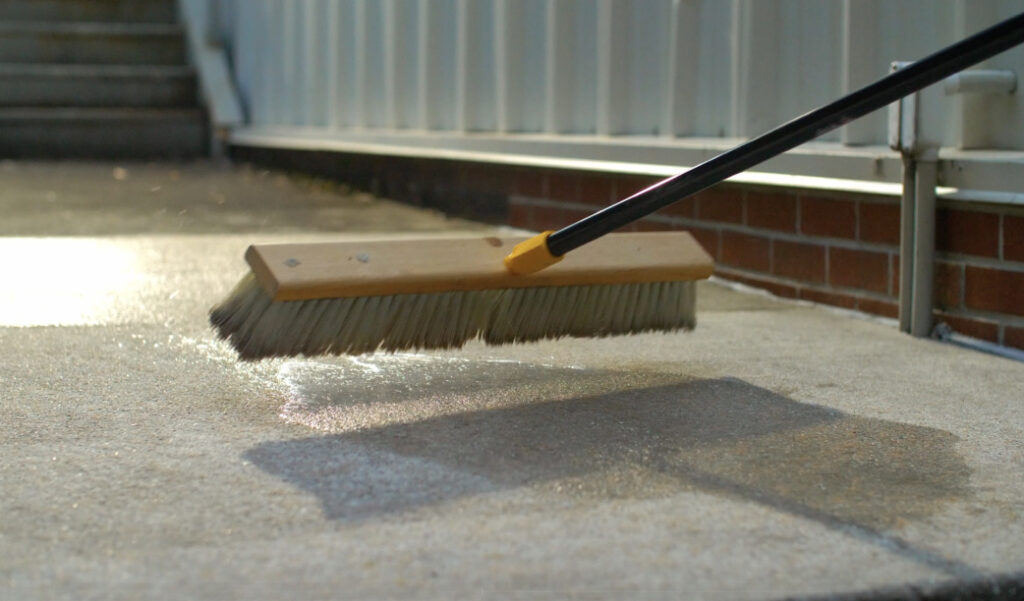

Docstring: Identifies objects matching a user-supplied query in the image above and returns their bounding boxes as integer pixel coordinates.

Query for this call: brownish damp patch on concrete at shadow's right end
[668,416,971,530]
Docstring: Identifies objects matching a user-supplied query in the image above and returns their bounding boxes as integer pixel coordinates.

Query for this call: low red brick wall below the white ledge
[233,147,1024,348]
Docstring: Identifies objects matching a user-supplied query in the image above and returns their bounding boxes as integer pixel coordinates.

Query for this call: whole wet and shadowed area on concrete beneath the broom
[246,355,970,533]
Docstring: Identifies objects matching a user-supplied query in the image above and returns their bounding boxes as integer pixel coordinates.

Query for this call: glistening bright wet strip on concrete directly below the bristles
[279,353,685,433]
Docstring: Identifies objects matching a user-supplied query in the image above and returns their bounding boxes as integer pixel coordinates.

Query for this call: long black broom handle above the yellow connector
[548,12,1024,256]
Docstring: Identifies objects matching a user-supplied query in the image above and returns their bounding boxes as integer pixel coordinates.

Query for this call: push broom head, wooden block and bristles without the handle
[210,231,713,359]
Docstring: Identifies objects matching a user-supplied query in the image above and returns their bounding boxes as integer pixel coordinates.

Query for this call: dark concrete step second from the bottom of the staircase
[0,63,197,106]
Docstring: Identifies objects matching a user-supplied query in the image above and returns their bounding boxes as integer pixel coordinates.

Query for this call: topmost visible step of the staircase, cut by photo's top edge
[0,0,177,23]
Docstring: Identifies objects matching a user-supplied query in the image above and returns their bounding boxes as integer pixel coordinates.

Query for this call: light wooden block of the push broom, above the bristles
[246,231,714,301]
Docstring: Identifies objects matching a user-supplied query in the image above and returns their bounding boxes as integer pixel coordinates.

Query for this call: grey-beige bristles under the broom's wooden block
[210,273,696,359]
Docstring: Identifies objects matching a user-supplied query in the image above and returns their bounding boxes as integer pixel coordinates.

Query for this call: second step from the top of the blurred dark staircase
[0,22,185,65]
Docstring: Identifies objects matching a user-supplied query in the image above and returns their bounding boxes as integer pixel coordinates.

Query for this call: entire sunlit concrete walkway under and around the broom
[0,163,1024,600]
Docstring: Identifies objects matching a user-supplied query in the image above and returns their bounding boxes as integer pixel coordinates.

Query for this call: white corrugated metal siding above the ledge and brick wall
[214,0,1024,191]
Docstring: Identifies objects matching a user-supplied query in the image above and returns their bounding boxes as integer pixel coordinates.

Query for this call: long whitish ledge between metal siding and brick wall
[231,127,1024,205]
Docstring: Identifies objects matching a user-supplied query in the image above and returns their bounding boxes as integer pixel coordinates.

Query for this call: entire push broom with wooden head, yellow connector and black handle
[210,13,1024,359]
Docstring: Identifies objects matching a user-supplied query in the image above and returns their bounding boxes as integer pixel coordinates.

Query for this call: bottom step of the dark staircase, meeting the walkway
[0,109,208,159]
